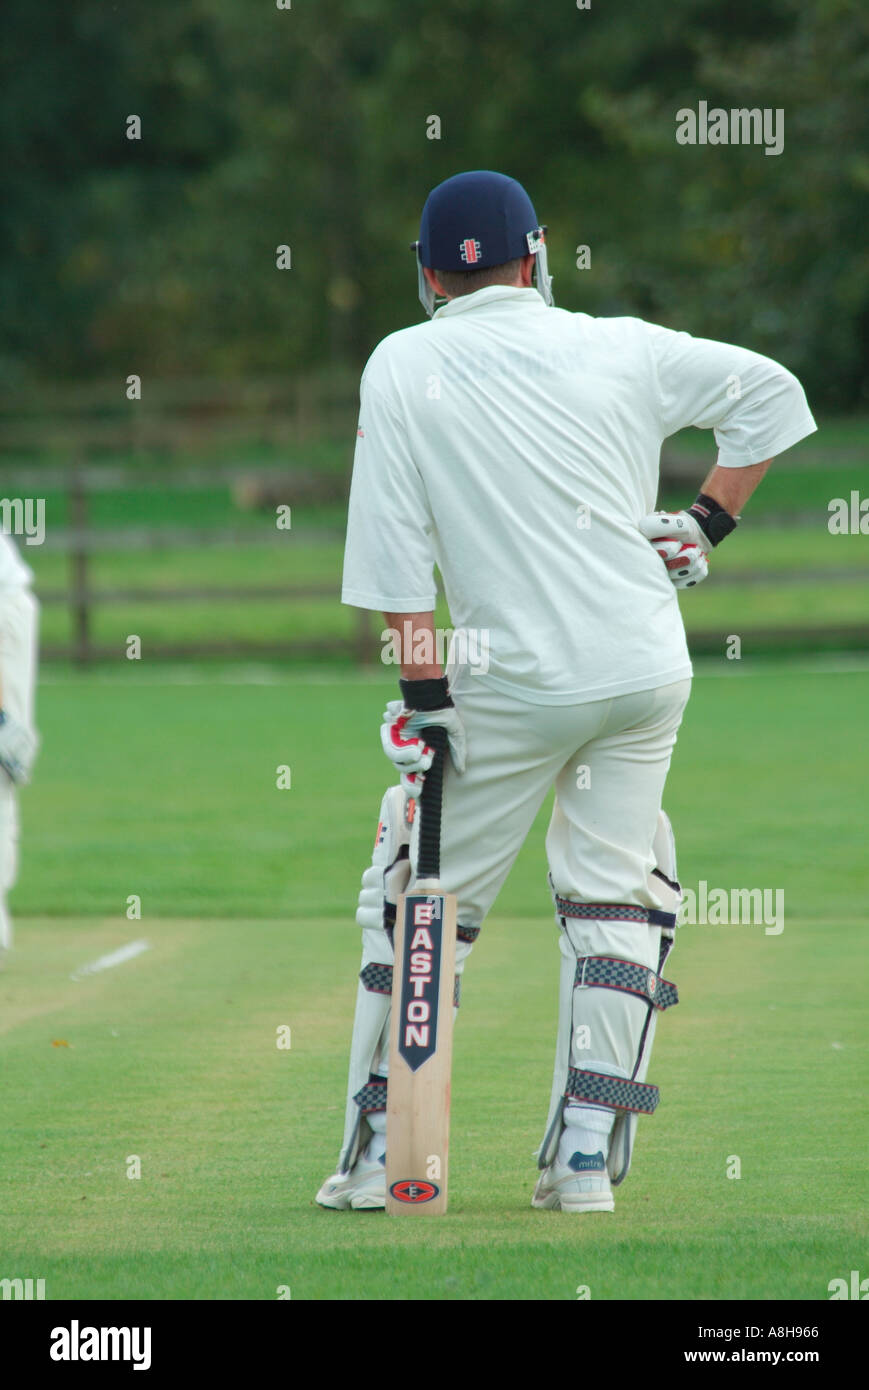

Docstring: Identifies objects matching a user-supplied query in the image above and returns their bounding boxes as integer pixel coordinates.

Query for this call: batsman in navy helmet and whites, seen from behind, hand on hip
[317,171,816,1213]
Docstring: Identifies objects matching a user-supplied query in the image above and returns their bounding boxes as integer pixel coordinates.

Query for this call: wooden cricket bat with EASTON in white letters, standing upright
[387,727,456,1216]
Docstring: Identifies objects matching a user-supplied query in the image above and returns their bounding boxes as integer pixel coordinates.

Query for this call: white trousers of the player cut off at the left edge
[0,588,39,949]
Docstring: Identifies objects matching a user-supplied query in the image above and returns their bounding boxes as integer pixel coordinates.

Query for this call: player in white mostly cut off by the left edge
[0,531,39,962]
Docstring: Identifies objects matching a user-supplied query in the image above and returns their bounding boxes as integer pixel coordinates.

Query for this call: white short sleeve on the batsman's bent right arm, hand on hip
[647,324,818,468]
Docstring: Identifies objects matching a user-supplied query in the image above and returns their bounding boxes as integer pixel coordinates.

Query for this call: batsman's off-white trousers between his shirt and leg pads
[441,667,691,922]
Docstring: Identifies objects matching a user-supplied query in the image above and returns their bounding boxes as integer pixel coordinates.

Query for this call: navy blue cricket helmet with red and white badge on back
[412,170,553,317]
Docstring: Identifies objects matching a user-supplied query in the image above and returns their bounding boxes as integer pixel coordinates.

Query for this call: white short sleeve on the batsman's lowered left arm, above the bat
[341,377,435,613]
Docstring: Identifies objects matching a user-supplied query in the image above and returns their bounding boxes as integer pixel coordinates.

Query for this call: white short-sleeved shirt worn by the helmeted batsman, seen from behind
[342,285,816,705]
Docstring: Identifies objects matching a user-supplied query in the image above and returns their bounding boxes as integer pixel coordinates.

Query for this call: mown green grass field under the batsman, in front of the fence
[0,667,869,1300]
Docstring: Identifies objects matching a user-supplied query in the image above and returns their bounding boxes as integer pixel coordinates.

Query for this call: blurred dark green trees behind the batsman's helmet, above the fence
[0,0,869,407]
